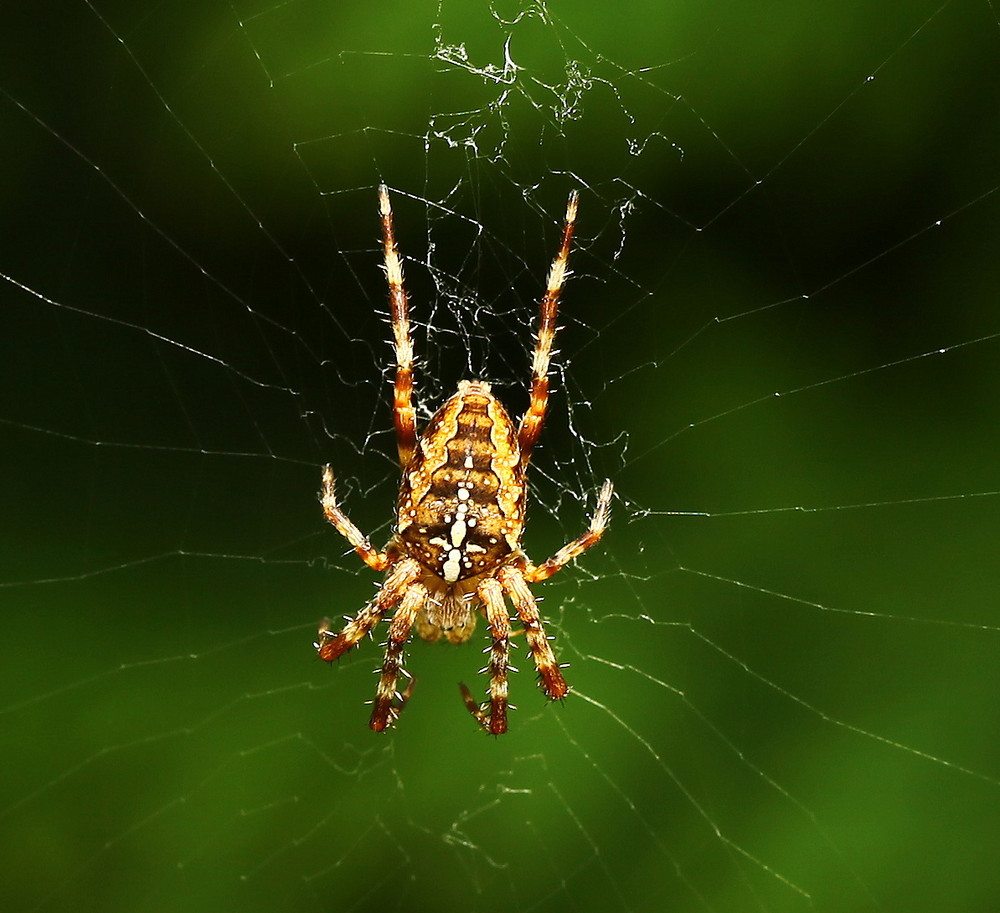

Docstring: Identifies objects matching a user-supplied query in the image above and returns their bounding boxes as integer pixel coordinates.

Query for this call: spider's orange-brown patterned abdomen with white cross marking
[397,381,525,584]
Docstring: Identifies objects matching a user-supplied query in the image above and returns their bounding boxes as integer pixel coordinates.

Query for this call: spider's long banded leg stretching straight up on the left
[378,184,417,469]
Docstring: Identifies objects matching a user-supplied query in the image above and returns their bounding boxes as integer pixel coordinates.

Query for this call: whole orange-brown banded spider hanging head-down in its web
[315,184,612,735]
